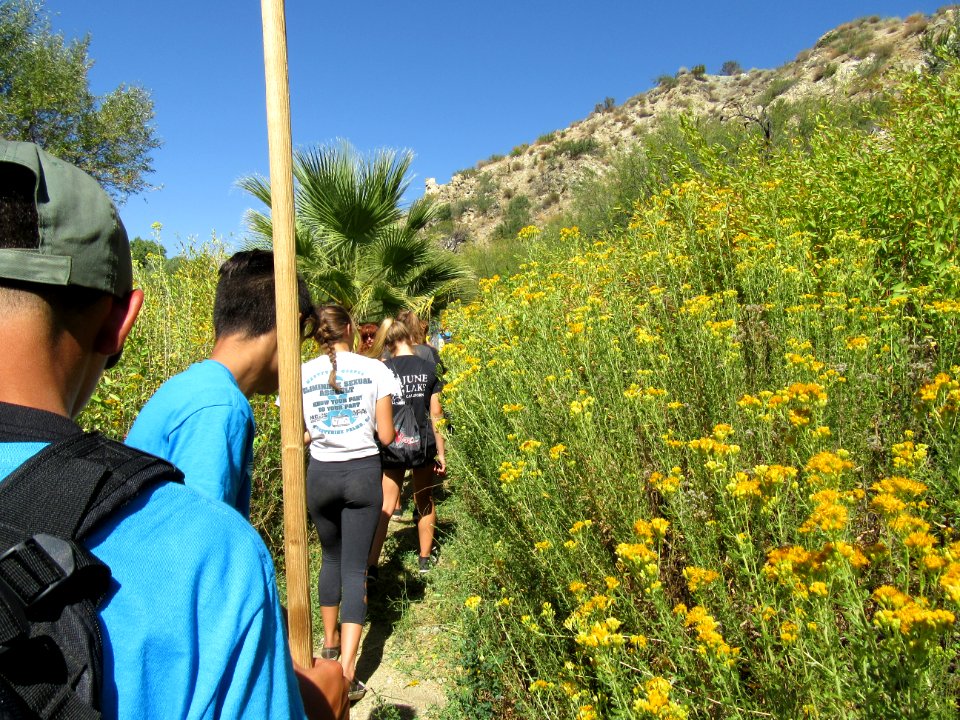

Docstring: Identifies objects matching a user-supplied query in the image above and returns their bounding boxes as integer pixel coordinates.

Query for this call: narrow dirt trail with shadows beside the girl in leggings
[350,505,445,720]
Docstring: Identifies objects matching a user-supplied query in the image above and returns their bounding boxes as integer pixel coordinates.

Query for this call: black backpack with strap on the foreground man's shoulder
[0,433,183,720]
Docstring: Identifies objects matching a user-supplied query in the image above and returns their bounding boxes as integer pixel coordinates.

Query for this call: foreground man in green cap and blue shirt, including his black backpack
[0,141,346,720]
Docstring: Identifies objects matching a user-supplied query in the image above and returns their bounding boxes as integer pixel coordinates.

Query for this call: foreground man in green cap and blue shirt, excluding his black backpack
[0,141,347,718]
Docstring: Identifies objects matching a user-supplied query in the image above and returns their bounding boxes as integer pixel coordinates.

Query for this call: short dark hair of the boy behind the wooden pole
[213,250,316,340]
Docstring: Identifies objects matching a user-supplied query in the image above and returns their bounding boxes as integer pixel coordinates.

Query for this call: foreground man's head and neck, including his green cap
[0,140,143,416]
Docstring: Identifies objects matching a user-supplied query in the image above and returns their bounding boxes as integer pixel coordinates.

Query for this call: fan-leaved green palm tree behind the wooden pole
[238,143,473,320]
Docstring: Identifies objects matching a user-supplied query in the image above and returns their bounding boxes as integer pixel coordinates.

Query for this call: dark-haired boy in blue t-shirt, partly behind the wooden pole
[126,250,316,518]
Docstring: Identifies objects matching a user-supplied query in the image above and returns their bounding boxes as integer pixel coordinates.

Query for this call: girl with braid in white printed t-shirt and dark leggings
[301,305,397,700]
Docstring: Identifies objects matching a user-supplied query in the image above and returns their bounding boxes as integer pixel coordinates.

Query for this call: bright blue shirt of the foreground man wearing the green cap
[0,434,305,720]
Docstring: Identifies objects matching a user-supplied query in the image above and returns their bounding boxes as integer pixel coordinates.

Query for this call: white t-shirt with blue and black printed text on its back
[301,352,400,461]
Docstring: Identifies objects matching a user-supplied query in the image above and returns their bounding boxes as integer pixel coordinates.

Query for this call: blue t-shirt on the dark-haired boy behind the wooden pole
[126,360,255,518]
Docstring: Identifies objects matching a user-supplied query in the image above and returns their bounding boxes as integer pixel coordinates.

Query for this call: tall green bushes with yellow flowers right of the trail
[434,52,960,720]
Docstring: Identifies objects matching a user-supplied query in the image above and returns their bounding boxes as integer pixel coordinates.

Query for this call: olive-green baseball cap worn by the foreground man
[0,140,133,297]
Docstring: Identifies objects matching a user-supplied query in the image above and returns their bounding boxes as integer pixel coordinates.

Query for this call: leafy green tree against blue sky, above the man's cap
[0,0,160,201]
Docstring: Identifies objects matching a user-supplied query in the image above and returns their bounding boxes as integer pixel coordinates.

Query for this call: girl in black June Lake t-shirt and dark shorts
[367,318,447,578]
